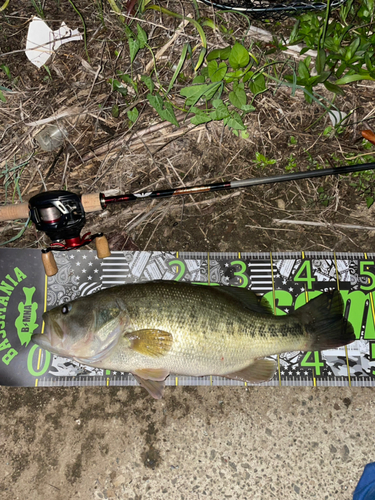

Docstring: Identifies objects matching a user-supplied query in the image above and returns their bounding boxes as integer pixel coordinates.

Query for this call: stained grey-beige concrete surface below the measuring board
[0,387,375,500]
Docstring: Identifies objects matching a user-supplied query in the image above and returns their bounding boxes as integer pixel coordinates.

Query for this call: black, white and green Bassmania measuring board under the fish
[0,249,375,387]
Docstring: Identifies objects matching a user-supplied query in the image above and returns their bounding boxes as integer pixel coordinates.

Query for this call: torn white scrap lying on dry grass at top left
[26,16,83,68]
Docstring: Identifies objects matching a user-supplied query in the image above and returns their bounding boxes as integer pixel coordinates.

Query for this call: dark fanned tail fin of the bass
[293,290,356,351]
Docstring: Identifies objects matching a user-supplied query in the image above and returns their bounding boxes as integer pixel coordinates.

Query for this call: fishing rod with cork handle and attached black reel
[0,131,375,276]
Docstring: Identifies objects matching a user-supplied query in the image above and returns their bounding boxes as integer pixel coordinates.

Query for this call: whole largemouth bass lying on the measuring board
[32,281,355,398]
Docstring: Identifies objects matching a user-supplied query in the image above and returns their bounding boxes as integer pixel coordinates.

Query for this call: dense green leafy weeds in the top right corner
[286,0,375,102]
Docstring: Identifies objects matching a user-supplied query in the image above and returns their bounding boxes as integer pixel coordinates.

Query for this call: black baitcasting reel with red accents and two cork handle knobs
[29,191,111,276]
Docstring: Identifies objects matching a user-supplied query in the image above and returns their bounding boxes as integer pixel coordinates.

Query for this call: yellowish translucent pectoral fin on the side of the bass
[124,329,173,358]
